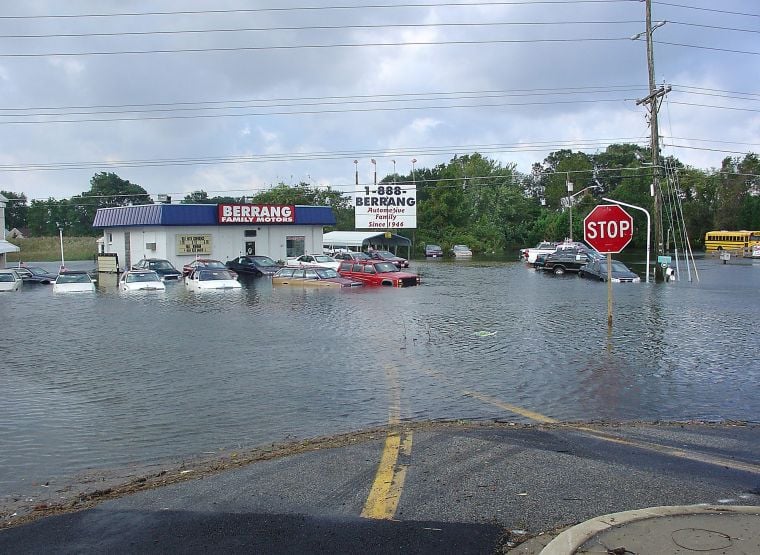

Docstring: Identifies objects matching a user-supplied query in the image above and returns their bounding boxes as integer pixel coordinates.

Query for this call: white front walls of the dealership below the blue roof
[103,224,323,271]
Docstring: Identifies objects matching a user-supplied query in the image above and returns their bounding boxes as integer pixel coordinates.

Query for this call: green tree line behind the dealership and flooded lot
[0,144,760,253]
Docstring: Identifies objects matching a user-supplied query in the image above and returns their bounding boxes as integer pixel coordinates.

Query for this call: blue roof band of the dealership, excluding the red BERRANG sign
[92,204,335,227]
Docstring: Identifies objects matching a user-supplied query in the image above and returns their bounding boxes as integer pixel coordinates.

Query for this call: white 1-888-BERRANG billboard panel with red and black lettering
[354,183,417,229]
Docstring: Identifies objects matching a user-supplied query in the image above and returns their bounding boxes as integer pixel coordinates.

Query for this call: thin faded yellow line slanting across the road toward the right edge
[464,391,760,474]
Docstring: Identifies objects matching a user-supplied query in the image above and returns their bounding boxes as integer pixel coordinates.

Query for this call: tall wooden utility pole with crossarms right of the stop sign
[634,0,670,282]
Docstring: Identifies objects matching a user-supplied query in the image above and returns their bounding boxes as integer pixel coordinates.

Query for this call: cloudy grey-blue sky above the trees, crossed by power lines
[0,0,760,199]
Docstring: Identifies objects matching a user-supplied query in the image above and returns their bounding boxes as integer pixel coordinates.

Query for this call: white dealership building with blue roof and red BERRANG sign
[93,204,335,271]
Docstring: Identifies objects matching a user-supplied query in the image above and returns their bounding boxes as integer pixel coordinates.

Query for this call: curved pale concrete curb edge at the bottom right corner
[540,505,760,555]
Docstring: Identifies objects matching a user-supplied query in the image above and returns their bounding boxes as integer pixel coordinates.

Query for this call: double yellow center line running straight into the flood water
[361,366,412,520]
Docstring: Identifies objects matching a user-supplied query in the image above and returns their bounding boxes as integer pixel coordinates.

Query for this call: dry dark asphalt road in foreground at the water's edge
[0,423,760,553]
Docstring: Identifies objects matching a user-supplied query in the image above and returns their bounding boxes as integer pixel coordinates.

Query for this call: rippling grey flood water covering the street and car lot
[0,259,760,498]
